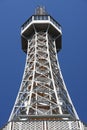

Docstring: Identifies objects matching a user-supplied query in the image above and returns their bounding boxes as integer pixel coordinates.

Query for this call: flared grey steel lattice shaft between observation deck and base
[10,31,78,120]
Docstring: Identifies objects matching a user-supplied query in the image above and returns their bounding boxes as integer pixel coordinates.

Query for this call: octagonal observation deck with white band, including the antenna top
[21,6,62,52]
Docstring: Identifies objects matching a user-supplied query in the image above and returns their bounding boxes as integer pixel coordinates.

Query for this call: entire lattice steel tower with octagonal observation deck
[1,7,86,130]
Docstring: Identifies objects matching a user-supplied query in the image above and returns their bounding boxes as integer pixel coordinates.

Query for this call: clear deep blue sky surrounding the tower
[0,0,87,127]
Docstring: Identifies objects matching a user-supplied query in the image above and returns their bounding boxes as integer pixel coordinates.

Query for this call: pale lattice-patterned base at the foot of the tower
[0,116,87,130]
